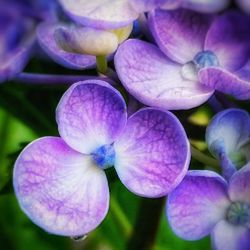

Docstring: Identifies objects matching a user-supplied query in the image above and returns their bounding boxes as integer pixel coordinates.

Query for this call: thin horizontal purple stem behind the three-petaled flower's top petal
[15,73,113,85]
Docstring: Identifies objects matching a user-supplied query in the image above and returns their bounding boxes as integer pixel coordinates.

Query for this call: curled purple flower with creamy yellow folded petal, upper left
[37,22,132,69]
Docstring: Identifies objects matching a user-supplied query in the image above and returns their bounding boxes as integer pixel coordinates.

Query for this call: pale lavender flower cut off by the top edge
[59,0,229,29]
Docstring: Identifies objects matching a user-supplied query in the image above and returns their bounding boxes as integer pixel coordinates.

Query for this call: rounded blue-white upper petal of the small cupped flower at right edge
[206,109,250,154]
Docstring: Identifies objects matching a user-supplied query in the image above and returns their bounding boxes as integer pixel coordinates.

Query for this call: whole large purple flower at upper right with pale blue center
[115,9,250,110]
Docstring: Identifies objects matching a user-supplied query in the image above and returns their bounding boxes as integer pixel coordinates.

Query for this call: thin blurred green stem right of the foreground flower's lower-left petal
[110,196,132,237]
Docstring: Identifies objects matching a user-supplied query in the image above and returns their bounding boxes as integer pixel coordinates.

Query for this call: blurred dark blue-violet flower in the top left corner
[0,1,35,83]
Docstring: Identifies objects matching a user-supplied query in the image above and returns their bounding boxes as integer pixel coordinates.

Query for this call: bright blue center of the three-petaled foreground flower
[91,144,115,169]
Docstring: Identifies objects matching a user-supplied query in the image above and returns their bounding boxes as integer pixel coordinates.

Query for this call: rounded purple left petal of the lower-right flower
[166,170,230,240]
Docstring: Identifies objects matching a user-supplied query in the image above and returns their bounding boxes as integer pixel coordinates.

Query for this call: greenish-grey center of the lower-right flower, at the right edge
[227,202,250,228]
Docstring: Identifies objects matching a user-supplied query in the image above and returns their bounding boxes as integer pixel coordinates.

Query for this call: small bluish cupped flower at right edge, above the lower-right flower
[206,109,250,178]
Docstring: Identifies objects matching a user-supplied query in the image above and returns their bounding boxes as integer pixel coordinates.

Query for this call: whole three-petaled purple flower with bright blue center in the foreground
[13,80,190,236]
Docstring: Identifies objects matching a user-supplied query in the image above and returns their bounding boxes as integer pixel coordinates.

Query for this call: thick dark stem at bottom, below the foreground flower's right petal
[127,198,165,250]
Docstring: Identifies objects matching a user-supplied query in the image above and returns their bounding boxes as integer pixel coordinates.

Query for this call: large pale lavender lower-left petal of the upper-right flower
[115,40,213,110]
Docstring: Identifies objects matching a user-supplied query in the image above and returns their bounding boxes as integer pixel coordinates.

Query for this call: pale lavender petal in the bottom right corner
[211,220,250,250]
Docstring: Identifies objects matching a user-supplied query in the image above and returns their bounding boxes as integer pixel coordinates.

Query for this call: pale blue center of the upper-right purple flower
[193,50,219,70]
